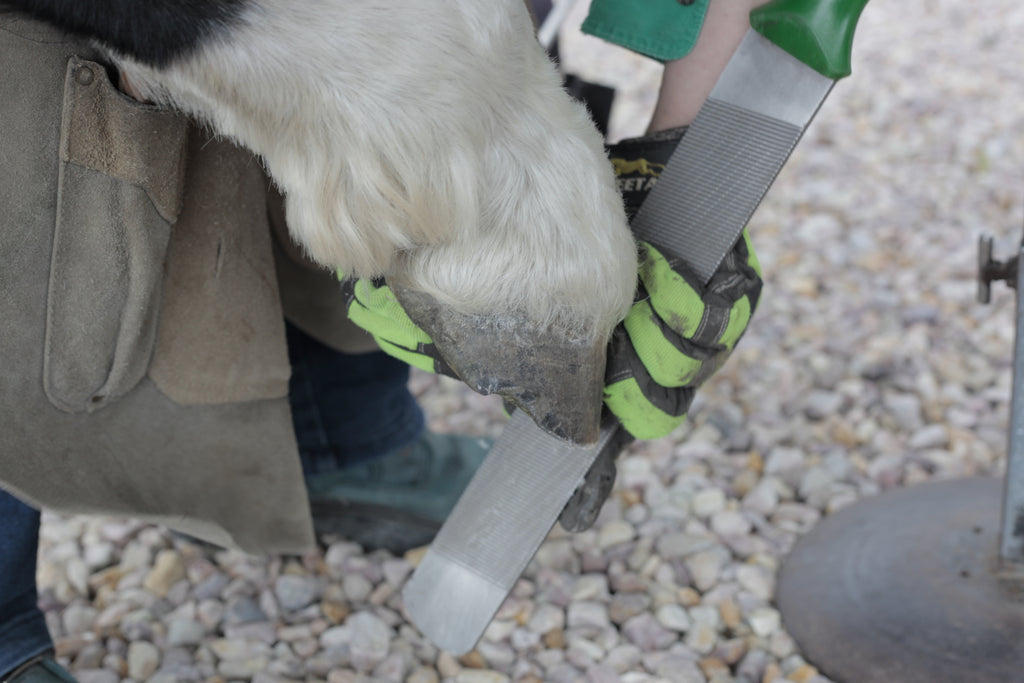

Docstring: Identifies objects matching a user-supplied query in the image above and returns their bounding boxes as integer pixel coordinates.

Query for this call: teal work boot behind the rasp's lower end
[306,432,493,554]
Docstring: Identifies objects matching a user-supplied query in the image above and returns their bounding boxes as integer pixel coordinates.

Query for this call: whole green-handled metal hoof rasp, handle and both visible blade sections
[402,0,867,653]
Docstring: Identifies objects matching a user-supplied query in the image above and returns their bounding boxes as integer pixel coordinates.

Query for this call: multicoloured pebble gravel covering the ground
[32,0,1024,683]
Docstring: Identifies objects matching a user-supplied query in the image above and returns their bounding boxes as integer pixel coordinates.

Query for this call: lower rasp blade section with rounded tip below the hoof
[402,411,617,654]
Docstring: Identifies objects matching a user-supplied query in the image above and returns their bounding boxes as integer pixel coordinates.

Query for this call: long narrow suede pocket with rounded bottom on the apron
[43,57,187,413]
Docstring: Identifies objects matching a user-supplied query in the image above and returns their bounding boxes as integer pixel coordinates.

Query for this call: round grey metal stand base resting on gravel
[776,478,1024,683]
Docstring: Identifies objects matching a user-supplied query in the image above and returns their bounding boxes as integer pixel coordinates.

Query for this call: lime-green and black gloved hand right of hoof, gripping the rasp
[604,128,762,439]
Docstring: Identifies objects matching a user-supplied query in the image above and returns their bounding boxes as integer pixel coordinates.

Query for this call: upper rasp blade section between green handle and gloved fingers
[633,31,835,283]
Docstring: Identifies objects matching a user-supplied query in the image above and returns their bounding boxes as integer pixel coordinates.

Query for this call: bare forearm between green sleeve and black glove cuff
[647,0,768,133]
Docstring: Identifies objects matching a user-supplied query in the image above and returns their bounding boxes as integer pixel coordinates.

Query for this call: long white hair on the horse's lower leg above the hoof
[115,0,636,340]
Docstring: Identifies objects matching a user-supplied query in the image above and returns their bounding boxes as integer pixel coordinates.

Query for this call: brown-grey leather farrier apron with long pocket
[0,9,370,553]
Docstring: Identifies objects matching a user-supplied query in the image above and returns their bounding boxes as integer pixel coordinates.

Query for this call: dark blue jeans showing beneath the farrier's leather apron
[0,325,424,678]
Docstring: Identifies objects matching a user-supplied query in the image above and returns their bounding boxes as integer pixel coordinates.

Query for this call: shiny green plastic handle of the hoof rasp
[751,0,867,81]
